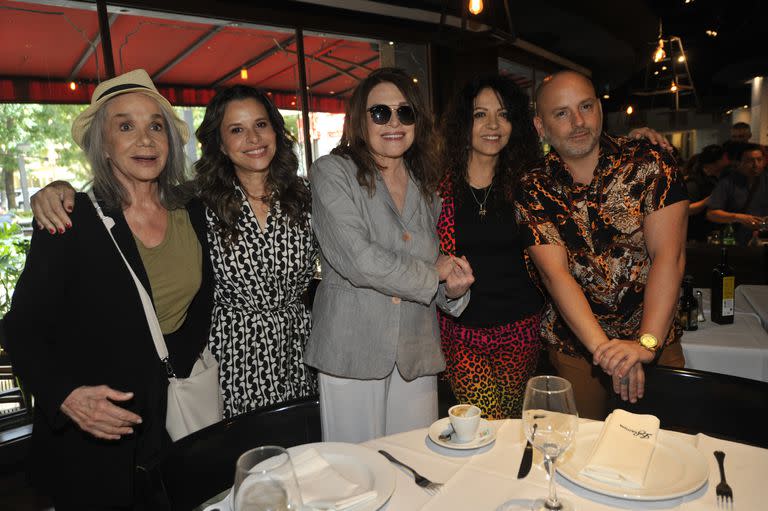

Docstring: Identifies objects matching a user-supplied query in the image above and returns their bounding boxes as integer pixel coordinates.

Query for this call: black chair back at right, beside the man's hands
[611,366,768,447]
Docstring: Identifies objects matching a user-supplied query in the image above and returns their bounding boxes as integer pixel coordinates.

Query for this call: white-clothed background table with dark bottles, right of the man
[681,286,768,381]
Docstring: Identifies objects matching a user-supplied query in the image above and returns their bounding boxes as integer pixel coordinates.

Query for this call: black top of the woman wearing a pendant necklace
[454,184,544,327]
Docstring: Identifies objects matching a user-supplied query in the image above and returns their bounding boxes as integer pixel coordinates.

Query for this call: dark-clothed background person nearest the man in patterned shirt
[685,144,730,241]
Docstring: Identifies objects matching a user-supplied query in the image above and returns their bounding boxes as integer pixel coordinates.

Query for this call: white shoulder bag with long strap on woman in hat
[88,191,223,442]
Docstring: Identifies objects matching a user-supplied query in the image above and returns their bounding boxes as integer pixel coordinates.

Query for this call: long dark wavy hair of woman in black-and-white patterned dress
[195,85,311,242]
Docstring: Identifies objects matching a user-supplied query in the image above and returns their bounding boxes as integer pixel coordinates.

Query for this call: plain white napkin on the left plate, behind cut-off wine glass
[204,448,378,511]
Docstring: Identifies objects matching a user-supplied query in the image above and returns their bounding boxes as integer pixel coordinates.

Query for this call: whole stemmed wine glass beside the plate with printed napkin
[523,376,579,511]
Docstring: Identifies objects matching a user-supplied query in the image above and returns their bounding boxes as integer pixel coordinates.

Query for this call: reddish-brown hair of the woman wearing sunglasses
[331,67,443,201]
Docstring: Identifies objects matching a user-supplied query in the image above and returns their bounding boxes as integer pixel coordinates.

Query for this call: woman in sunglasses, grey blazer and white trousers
[305,68,474,442]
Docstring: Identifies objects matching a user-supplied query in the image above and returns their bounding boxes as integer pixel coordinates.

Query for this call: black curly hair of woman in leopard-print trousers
[441,76,542,211]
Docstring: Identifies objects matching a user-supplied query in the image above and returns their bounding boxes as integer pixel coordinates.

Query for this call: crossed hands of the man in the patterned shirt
[592,339,653,403]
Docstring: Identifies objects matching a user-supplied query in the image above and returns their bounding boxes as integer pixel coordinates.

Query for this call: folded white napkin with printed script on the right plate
[581,410,659,488]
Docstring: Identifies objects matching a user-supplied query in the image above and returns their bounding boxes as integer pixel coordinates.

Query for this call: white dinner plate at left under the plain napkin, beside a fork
[288,442,396,511]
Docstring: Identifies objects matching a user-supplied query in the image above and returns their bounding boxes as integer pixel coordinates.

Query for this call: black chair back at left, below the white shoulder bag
[139,398,321,511]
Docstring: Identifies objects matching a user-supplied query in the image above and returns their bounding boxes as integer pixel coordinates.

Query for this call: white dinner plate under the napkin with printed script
[556,422,709,500]
